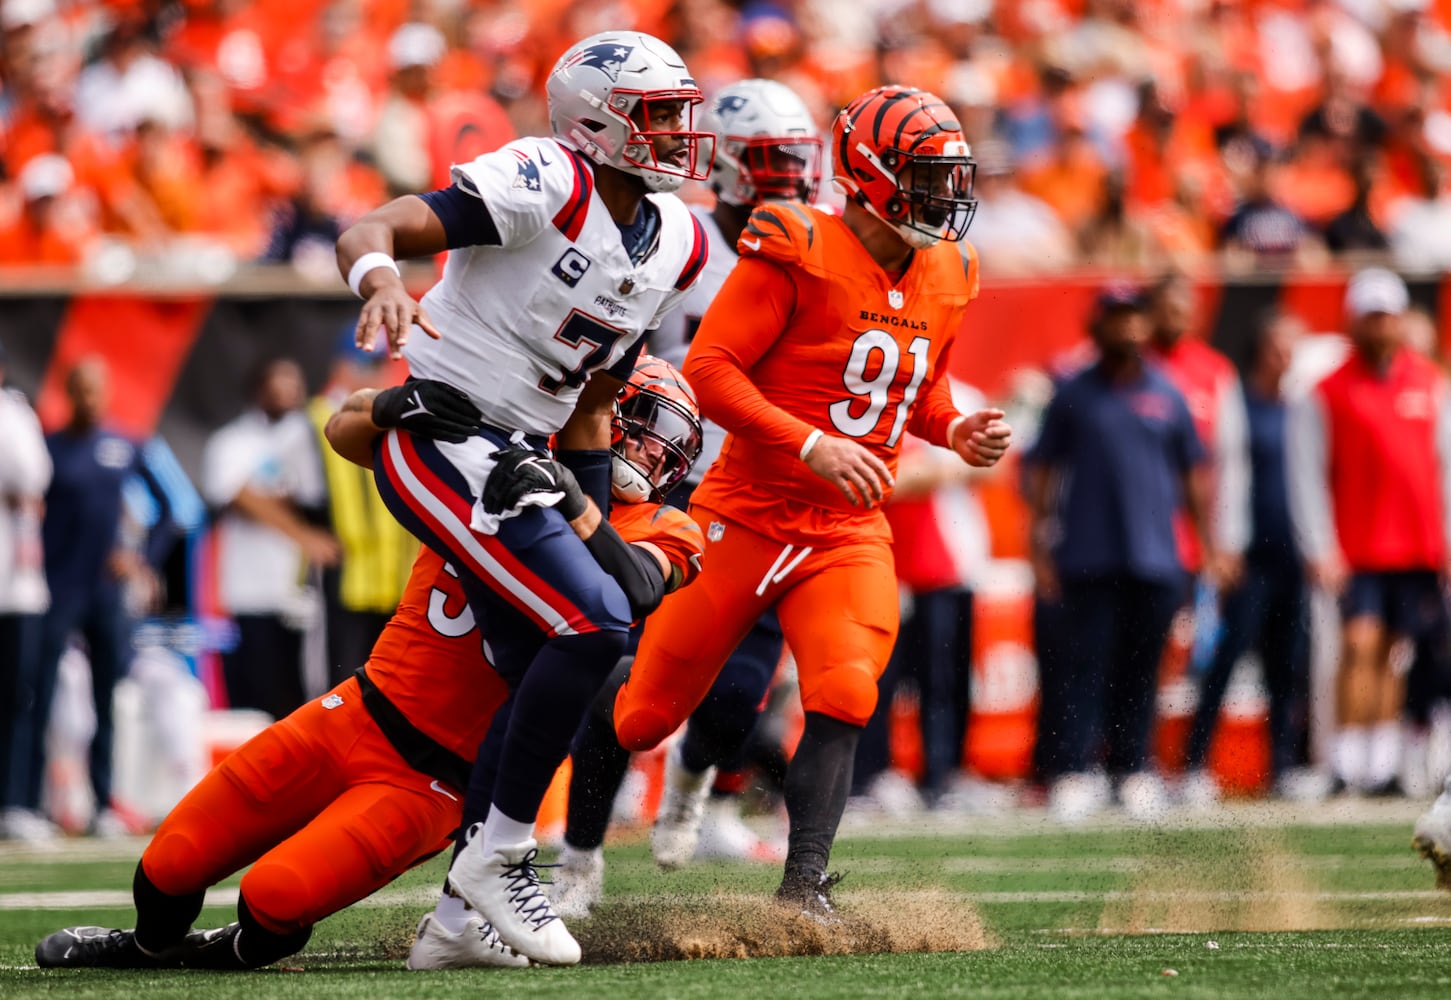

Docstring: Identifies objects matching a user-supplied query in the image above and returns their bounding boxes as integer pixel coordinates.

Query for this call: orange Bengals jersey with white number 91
[683,203,978,546]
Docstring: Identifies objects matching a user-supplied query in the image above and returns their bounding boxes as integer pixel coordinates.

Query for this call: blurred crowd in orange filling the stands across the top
[0,0,1451,283]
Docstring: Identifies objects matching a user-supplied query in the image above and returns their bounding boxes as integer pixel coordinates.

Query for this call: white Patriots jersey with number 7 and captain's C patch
[403,138,708,435]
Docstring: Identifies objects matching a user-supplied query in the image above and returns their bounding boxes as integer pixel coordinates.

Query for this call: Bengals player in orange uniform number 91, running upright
[614,86,1011,919]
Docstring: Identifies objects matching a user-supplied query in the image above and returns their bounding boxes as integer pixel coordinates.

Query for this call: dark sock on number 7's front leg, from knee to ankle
[493,631,628,821]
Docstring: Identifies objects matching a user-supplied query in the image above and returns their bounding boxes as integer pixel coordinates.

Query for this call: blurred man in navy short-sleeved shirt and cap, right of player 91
[1024,284,1207,820]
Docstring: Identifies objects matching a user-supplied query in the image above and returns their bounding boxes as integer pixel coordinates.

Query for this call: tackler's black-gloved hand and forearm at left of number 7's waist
[322,379,483,469]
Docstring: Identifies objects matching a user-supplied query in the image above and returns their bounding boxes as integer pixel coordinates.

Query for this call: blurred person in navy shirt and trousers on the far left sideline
[9,357,176,836]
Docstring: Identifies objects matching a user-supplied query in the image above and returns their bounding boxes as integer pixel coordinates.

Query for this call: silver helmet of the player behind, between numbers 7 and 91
[701,80,821,206]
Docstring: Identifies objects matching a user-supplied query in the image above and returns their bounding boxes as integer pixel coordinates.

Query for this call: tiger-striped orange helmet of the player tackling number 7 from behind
[609,354,701,504]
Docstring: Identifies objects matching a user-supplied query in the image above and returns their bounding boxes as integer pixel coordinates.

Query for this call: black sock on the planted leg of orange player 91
[786,711,862,882]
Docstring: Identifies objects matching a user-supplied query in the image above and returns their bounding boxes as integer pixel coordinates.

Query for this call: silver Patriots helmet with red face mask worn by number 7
[546,30,714,192]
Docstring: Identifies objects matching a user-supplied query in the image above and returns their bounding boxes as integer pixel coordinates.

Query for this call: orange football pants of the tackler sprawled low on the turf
[141,678,463,935]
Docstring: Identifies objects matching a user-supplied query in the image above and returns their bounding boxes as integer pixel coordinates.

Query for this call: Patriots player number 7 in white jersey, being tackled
[338,30,711,964]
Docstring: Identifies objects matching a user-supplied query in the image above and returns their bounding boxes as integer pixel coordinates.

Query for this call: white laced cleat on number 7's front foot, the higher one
[448,823,579,965]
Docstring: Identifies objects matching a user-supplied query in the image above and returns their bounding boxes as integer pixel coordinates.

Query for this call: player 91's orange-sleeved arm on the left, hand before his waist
[682,257,892,507]
